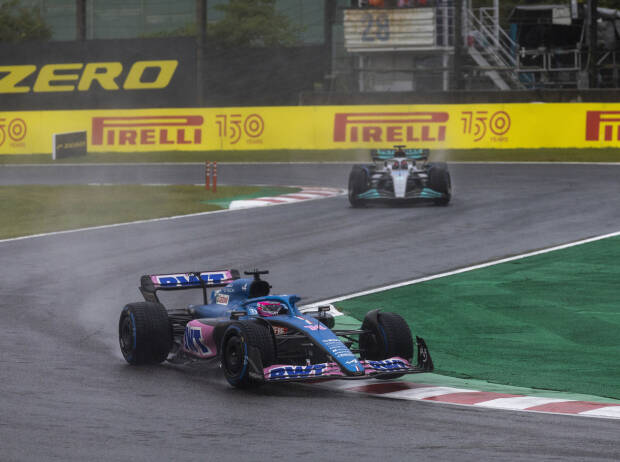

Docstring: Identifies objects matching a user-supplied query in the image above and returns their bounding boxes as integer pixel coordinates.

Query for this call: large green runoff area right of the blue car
[337,237,620,399]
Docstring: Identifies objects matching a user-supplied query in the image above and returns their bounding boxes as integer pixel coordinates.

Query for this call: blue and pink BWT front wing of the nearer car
[263,356,429,382]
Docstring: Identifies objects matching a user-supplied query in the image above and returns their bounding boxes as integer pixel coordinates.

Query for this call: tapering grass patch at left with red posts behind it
[0,185,299,239]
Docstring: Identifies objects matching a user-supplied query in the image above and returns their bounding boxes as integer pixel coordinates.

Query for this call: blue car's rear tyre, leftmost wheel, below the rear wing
[118,302,172,365]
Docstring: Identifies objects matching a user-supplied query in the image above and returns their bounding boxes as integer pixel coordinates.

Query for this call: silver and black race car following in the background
[349,146,452,207]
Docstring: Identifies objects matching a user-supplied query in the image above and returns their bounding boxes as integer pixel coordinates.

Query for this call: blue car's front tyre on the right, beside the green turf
[359,310,413,379]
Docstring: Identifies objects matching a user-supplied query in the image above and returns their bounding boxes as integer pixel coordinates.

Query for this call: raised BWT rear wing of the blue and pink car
[139,269,239,304]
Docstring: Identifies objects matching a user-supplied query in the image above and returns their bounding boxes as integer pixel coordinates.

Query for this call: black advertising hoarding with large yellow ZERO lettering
[0,37,197,110]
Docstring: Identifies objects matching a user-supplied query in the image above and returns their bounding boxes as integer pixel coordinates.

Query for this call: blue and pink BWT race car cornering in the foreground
[118,270,433,388]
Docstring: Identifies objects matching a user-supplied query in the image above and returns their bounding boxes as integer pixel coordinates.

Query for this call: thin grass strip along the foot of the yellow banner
[0,148,620,165]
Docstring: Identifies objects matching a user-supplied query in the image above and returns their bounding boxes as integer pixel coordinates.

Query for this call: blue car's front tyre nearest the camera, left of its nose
[220,321,276,388]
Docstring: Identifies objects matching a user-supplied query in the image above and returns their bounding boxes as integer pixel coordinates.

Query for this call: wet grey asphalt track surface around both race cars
[0,164,620,461]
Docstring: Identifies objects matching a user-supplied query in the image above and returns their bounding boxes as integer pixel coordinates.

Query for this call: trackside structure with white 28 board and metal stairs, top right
[344,0,620,91]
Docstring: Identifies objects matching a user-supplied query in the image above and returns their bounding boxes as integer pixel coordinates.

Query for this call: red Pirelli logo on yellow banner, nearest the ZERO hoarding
[92,115,204,146]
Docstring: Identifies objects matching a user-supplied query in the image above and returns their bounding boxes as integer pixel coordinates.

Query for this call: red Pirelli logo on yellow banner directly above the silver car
[334,112,450,143]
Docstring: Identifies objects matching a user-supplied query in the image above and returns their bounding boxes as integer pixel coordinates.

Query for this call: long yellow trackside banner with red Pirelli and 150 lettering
[0,103,620,154]
